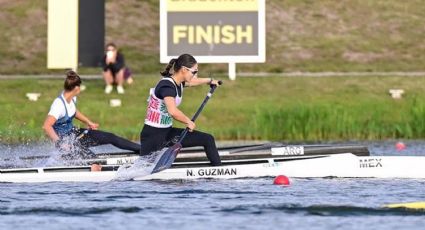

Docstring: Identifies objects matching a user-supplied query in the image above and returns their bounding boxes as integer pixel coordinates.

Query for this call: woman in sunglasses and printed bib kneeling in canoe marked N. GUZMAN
[140,54,221,166]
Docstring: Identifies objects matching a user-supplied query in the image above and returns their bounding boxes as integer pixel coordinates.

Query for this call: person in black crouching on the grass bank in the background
[102,43,133,94]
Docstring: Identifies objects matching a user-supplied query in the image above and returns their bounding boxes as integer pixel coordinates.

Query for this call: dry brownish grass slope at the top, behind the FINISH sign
[0,0,425,74]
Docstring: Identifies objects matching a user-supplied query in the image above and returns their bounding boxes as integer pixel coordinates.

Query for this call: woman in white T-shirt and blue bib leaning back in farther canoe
[43,70,140,157]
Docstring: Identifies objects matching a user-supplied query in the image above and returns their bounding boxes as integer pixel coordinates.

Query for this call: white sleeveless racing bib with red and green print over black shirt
[145,77,183,128]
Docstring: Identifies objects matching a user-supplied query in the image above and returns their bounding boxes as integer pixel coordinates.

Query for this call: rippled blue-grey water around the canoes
[0,141,425,230]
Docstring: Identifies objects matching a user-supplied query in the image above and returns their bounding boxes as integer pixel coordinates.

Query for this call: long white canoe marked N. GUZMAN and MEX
[0,146,425,182]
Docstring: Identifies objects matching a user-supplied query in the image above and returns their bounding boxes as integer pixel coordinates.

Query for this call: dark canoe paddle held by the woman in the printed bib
[152,81,223,173]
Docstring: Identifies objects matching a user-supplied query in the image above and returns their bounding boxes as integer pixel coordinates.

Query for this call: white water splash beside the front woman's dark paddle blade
[114,148,167,181]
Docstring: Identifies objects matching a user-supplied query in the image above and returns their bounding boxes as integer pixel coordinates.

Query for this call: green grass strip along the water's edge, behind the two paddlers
[0,76,425,143]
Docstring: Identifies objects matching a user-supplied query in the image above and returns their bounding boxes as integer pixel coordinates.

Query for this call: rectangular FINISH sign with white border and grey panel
[160,0,265,63]
